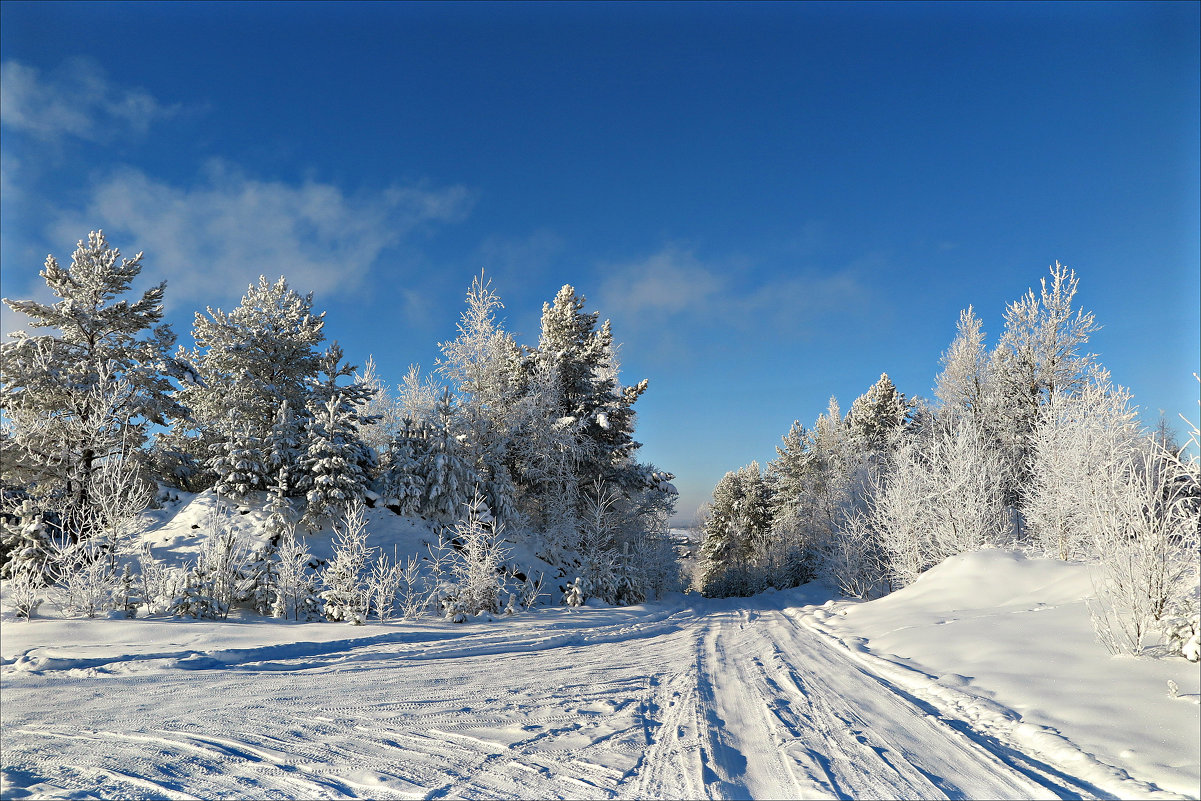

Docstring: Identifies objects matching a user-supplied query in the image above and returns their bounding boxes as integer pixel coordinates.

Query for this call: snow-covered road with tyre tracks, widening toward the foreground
[2,594,1152,799]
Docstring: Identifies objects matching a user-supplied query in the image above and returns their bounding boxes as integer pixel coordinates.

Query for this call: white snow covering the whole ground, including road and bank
[0,521,1201,799]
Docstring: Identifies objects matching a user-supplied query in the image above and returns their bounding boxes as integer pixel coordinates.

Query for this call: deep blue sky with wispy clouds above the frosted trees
[0,0,1201,518]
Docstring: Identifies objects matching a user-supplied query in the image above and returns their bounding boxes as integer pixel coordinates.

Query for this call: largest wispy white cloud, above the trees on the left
[47,162,472,306]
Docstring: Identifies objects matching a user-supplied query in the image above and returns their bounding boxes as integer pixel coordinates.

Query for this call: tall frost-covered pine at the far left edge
[0,231,186,525]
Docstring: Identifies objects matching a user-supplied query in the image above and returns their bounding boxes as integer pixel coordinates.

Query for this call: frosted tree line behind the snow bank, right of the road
[694,263,1201,659]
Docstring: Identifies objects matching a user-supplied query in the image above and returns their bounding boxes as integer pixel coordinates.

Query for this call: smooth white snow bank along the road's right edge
[814,549,1201,797]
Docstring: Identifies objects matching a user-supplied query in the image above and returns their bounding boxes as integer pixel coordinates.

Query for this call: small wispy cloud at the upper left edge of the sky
[0,58,181,142]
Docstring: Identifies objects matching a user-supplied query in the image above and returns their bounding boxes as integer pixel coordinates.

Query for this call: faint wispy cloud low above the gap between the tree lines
[597,245,874,360]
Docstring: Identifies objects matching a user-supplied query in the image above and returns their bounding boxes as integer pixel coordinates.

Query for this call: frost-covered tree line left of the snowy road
[0,231,676,619]
